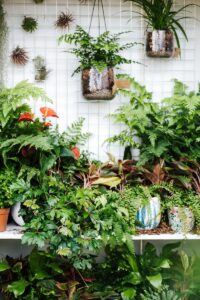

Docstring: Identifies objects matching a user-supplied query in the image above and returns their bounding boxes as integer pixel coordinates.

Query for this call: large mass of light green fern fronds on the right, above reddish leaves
[107,75,200,165]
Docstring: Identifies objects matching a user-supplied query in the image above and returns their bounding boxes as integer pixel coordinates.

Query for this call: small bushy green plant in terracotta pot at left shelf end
[0,169,15,232]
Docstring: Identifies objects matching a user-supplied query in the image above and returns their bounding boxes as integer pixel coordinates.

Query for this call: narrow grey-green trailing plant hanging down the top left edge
[0,0,8,88]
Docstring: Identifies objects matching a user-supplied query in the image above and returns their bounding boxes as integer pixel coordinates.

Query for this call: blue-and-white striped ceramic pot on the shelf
[136,197,161,230]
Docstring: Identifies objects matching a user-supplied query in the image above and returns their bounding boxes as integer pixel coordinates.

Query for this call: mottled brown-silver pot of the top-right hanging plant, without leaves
[146,30,174,58]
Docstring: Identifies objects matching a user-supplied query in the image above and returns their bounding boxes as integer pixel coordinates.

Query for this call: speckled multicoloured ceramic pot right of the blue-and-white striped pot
[168,207,195,233]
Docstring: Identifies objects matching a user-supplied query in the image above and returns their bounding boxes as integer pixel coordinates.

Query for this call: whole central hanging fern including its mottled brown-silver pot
[59,26,141,100]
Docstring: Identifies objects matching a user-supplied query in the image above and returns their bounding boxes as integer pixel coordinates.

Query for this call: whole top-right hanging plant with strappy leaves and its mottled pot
[125,0,198,58]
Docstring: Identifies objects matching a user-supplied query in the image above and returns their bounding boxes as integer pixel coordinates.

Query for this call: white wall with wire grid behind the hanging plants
[4,0,200,160]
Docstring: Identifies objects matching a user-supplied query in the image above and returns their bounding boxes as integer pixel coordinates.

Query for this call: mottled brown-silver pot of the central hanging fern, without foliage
[82,67,115,100]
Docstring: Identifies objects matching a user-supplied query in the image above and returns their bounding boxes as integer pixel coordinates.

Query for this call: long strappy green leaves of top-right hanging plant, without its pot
[125,0,198,48]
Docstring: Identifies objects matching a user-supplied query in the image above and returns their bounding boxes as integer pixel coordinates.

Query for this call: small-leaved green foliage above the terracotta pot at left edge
[0,169,16,208]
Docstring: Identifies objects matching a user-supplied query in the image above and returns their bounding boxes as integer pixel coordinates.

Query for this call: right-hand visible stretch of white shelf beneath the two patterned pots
[132,233,200,241]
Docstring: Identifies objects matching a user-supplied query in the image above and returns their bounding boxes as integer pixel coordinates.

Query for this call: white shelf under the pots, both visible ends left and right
[0,224,200,241]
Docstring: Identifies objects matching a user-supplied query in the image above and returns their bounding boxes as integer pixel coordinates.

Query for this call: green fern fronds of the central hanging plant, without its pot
[59,26,141,74]
